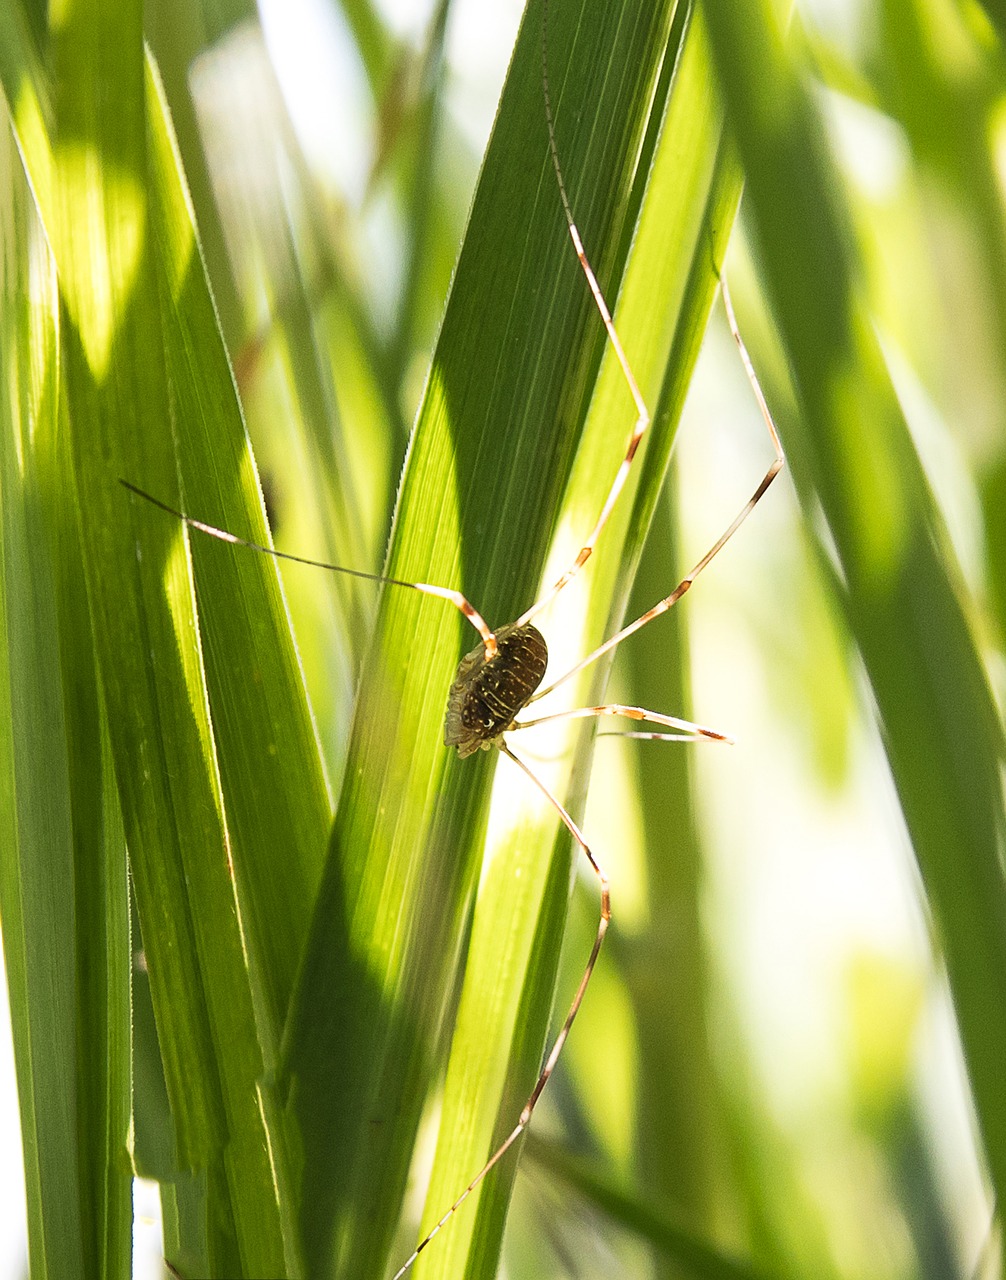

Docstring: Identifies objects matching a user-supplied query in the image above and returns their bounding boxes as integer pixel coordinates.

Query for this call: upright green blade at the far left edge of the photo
[0,112,132,1280]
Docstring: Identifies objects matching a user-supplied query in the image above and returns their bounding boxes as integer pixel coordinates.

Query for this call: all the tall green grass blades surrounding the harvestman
[0,0,1006,1277]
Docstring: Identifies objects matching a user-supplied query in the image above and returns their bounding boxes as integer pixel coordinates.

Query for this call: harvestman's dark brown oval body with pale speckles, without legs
[444,622,548,756]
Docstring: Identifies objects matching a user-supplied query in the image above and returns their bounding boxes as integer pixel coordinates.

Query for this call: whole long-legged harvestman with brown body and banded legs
[120,0,785,1280]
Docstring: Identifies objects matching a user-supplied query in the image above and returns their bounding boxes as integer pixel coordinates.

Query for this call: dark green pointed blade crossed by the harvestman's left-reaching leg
[137,55,330,1037]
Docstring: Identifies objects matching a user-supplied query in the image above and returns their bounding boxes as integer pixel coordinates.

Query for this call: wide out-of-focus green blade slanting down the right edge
[707,0,1006,1223]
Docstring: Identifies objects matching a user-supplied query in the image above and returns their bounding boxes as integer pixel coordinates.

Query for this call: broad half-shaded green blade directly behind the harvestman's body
[273,4,736,1275]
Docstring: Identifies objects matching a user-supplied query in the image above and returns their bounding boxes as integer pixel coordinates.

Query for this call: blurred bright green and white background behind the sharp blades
[0,0,1006,1280]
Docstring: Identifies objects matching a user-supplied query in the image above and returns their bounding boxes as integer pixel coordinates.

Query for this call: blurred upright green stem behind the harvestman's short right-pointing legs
[622,481,723,1229]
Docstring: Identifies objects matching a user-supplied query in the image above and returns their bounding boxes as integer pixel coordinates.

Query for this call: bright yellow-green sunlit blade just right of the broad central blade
[404,8,740,1276]
